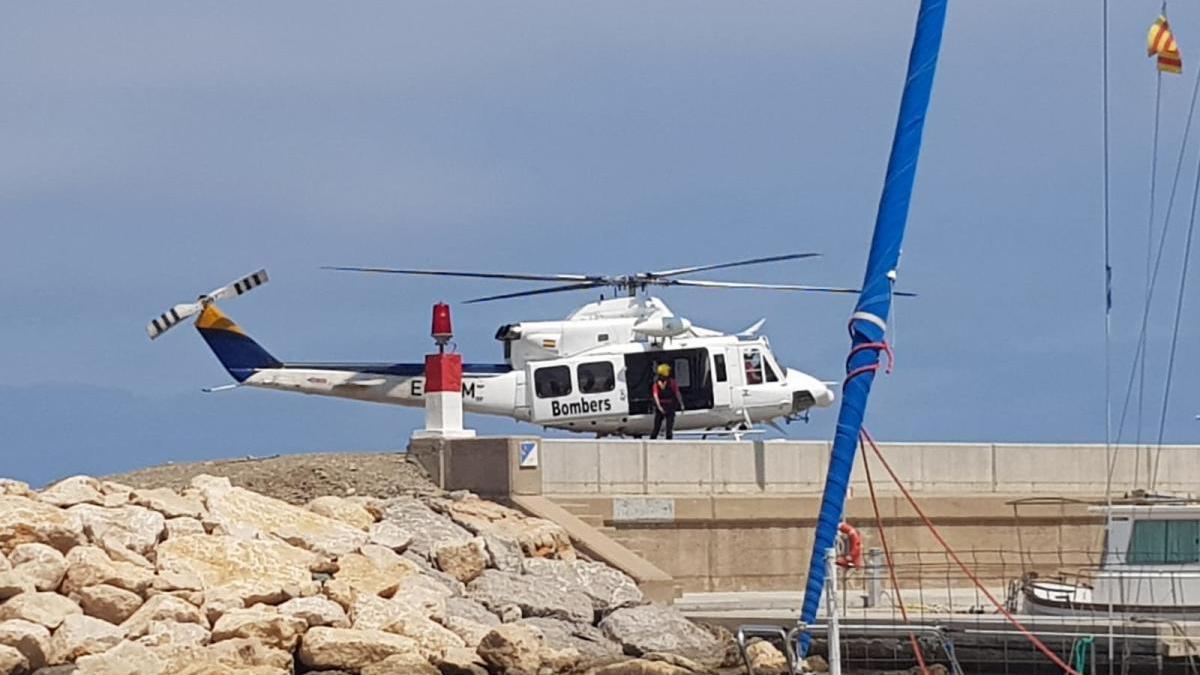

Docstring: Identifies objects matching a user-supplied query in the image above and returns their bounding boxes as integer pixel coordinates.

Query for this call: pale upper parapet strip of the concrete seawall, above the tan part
[541,438,1200,496]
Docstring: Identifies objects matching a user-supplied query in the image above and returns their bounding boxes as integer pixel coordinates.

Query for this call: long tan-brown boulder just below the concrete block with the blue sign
[433,495,575,560]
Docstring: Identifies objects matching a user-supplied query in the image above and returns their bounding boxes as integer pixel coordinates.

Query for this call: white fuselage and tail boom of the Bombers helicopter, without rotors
[242,322,834,435]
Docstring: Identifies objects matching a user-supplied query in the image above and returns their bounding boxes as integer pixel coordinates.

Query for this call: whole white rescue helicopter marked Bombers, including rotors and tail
[146,253,904,437]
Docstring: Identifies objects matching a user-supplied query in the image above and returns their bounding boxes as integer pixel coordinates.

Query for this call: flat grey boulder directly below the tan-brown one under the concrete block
[467,569,593,623]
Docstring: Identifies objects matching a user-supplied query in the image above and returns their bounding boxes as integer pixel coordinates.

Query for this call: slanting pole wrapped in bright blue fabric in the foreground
[800,0,947,653]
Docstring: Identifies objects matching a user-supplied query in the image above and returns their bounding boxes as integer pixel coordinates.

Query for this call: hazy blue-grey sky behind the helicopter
[0,0,1200,484]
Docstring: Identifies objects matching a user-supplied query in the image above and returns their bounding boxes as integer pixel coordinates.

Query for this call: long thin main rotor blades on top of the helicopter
[322,253,913,303]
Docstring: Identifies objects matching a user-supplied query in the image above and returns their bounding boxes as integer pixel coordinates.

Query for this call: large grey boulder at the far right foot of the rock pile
[600,604,725,668]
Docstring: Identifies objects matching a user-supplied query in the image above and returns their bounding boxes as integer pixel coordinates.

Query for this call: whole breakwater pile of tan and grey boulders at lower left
[0,476,748,675]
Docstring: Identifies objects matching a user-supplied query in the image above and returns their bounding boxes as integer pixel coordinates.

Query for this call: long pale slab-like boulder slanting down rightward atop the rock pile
[193,477,367,557]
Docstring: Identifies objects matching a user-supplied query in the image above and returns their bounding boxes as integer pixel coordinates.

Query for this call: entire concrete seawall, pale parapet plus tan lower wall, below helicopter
[408,437,1200,591]
